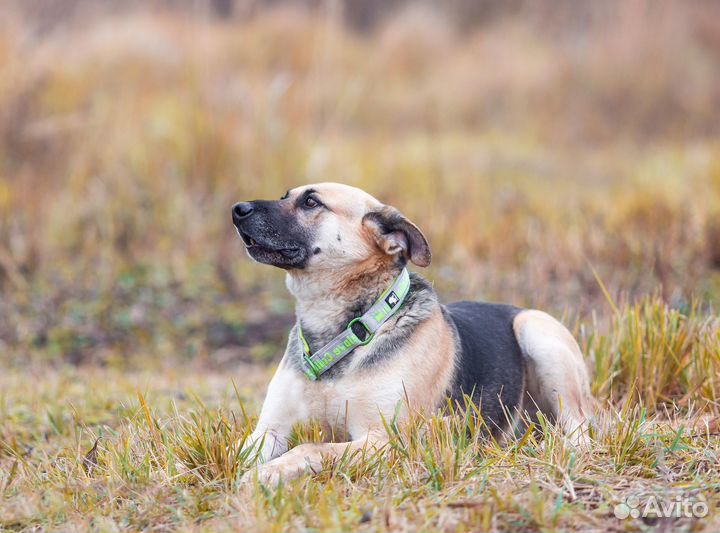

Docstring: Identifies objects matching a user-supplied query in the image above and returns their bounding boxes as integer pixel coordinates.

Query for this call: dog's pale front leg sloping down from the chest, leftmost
[242,361,308,463]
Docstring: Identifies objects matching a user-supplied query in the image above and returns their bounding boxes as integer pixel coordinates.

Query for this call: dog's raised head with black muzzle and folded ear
[232,183,430,272]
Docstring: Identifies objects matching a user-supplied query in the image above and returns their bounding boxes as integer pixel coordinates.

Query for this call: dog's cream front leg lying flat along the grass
[241,431,387,485]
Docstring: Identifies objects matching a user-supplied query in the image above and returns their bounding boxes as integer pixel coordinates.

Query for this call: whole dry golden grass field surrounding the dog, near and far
[0,0,720,532]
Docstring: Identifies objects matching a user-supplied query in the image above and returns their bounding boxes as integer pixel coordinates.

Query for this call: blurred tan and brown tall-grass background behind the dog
[0,0,720,369]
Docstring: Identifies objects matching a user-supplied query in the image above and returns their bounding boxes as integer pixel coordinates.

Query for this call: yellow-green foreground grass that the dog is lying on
[0,299,720,531]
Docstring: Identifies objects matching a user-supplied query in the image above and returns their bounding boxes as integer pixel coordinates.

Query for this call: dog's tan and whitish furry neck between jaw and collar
[286,265,403,344]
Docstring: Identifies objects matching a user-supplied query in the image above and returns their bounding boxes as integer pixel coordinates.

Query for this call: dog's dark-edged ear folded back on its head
[362,206,432,267]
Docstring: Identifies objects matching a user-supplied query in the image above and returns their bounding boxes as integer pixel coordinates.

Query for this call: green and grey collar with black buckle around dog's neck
[297,268,410,381]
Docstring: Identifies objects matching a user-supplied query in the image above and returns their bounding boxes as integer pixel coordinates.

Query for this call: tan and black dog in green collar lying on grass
[232,183,592,483]
